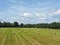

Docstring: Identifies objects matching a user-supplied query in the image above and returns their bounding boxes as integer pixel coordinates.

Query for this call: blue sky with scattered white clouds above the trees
[0,0,60,24]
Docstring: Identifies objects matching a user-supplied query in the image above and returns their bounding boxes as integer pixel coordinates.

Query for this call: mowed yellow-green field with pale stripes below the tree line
[0,28,60,45]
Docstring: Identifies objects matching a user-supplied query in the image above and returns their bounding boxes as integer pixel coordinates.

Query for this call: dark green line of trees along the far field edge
[0,22,60,29]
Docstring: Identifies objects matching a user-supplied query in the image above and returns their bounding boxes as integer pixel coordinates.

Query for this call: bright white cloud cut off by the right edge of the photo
[43,9,60,18]
